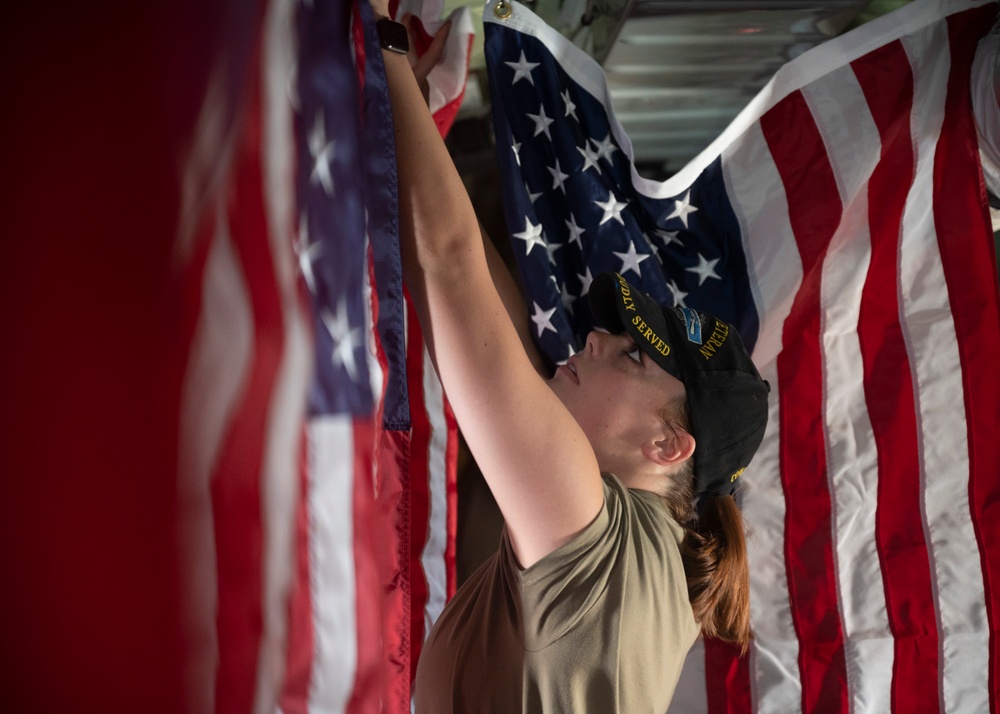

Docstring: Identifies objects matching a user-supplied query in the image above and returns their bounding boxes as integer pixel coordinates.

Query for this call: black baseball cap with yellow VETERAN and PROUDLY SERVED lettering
[588,273,770,496]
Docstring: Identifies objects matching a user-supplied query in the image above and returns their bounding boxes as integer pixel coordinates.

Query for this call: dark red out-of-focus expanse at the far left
[0,0,230,713]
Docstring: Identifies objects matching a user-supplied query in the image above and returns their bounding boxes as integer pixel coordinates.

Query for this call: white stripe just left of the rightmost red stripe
[900,25,990,712]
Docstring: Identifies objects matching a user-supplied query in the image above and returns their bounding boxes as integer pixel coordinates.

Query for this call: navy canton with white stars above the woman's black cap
[485,3,758,362]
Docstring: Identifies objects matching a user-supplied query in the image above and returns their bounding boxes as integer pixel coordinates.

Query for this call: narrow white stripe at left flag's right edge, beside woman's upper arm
[420,348,448,639]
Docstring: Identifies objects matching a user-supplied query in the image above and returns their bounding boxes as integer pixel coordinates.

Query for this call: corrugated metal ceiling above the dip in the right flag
[456,0,888,170]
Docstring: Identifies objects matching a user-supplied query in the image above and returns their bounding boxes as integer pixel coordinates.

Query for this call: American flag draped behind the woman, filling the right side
[484,0,1000,714]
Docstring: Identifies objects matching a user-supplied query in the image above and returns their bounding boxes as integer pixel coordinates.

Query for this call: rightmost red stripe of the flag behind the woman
[934,4,1000,712]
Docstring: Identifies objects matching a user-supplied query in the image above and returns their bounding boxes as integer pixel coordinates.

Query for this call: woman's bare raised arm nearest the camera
[374,2,603,567]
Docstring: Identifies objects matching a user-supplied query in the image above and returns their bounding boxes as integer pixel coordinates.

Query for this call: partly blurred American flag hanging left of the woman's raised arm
[176,0,472,713]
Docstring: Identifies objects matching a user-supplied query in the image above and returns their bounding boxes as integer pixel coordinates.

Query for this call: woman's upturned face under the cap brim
[549,331,685,471]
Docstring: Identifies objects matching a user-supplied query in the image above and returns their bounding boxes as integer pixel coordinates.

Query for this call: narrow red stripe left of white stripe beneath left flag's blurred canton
[279,431,316,714]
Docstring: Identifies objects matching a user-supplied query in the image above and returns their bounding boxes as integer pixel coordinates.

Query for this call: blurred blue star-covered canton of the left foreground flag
[294,0,373,416]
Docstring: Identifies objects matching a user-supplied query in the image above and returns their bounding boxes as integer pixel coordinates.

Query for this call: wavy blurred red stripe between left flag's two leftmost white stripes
[211,69,284,713]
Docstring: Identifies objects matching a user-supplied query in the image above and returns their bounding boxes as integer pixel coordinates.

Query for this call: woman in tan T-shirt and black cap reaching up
[374,9,767,712]
